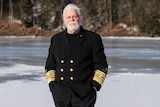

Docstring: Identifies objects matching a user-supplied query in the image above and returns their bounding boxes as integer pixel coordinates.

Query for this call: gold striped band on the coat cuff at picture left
[46,70,56,84]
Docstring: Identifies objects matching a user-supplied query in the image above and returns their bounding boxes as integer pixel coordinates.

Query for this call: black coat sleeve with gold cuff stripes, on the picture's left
[45,38,56,84]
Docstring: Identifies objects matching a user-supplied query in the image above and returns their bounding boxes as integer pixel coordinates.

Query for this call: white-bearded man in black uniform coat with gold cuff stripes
[45,4,108,107]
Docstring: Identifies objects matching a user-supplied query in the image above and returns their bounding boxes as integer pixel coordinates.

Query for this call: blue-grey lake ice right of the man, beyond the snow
[103,38,160,73]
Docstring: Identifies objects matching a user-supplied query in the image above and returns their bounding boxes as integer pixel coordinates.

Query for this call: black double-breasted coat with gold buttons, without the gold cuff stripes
[45,27,108,98]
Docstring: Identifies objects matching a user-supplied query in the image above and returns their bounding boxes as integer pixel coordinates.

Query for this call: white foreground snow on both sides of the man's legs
[0,73,160,107]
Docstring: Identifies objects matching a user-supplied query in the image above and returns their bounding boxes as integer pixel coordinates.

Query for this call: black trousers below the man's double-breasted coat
[50,82,96,107]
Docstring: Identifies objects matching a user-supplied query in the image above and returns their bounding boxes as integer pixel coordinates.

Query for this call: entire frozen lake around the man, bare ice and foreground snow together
[0,37,160,107]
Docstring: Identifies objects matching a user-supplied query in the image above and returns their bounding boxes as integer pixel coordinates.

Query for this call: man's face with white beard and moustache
[64,9,80,33]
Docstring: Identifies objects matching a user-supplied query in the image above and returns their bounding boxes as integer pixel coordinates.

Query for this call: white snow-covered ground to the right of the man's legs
[101,73,160,107]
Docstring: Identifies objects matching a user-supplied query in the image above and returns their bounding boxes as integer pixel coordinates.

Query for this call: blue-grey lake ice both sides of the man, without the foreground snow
[0,37,160,82]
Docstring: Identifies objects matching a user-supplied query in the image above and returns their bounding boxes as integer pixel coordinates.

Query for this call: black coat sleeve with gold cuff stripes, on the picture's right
[92,35,108,91]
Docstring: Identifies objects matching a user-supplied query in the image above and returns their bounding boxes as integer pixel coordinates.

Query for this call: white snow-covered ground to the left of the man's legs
[0,81,53,107]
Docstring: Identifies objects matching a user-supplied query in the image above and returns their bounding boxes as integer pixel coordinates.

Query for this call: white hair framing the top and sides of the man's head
[63,3,82,28]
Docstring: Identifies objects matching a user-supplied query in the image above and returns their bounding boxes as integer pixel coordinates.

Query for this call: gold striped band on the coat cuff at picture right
[93,70,106,86]
